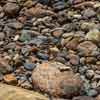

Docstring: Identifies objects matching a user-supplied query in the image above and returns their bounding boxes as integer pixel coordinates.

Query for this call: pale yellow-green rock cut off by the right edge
[85,29,100,42]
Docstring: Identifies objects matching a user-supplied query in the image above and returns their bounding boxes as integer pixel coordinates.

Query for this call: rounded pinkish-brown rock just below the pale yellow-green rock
[77,41,97,56]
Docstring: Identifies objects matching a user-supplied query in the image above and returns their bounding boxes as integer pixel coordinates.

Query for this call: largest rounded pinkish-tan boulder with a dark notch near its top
[32,62,82,98]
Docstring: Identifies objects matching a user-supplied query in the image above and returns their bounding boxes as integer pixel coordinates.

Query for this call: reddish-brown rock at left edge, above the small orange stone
[0,58,13,74]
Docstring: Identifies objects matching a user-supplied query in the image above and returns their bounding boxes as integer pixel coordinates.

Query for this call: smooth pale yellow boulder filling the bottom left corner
[0,84,49,100]
